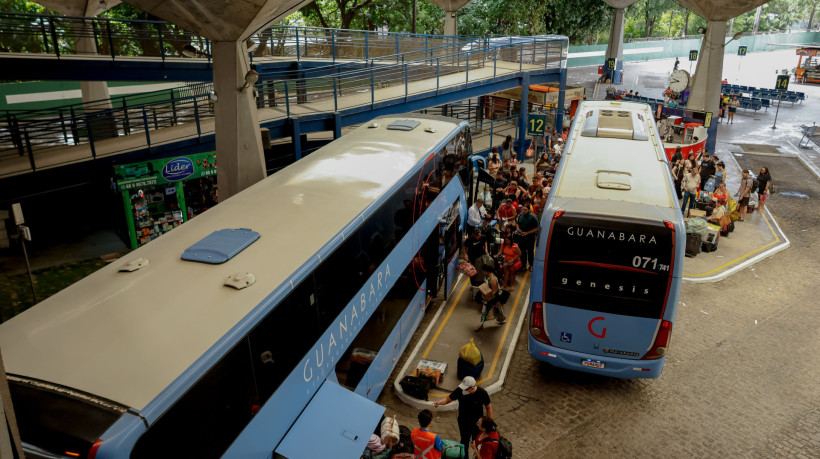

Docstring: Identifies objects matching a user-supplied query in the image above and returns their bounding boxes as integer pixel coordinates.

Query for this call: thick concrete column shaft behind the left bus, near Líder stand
[211,41,265,202]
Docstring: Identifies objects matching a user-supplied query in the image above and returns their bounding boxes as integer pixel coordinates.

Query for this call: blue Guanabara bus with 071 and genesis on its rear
[528,101,686,378]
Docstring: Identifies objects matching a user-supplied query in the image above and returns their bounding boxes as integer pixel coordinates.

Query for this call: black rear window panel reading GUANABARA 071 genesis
[544,214,674,318]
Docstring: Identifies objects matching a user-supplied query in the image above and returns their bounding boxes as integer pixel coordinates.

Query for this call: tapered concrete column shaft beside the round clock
[686,21,726,152]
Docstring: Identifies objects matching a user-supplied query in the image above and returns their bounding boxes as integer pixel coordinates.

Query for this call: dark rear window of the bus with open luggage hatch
[9,381,124,457]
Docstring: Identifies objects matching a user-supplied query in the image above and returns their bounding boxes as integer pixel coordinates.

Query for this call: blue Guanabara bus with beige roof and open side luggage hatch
[0,115,471,459]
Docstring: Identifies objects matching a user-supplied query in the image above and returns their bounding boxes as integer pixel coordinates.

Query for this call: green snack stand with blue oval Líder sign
[114,153,218,249]
